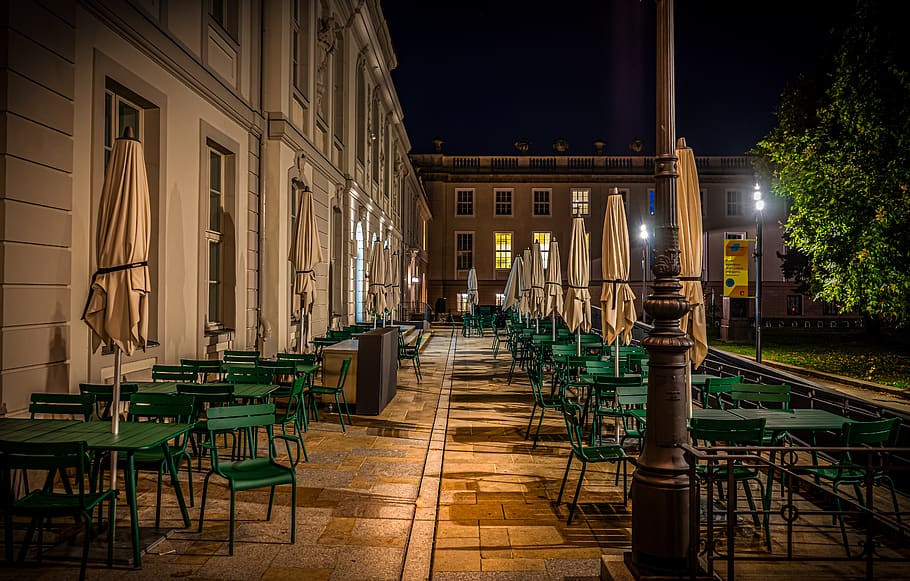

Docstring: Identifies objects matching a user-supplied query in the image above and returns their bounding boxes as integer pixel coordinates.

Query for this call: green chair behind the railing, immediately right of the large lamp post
[690,418,771,551]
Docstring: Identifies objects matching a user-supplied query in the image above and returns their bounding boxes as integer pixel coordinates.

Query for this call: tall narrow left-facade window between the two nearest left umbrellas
[205,147,224,329]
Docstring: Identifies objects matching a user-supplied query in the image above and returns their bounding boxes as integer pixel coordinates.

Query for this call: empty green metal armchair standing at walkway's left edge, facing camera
[199,403,297,555]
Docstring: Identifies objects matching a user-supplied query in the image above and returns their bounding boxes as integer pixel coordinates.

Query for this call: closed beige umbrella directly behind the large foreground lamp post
[676,137,708,367]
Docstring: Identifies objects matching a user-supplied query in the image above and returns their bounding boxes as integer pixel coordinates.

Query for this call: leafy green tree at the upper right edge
[755,0,910,327]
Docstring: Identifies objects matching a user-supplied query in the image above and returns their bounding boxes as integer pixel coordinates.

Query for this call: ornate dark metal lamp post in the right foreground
[626,0,698,579]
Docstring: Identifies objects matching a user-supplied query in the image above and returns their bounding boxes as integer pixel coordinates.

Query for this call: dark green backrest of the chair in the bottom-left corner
[0,440,90,496]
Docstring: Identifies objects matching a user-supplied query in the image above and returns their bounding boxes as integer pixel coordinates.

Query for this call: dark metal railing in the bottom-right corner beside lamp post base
[683,445,910,579]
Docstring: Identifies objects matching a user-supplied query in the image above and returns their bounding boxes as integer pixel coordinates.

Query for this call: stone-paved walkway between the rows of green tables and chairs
[7,327,904,581]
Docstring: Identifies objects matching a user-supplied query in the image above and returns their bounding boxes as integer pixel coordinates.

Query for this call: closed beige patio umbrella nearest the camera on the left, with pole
[82,129,152,488]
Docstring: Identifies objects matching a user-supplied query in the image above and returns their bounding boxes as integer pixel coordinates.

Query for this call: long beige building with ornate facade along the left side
[0,0,430,413]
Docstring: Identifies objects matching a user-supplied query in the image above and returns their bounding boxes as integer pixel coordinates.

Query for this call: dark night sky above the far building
[382,0,854,155]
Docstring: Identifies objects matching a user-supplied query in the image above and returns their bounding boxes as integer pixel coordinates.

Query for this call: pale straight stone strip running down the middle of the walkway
[401,326,457,581]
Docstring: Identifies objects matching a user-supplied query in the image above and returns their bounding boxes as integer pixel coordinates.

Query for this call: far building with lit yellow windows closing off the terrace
[412,143,823,325]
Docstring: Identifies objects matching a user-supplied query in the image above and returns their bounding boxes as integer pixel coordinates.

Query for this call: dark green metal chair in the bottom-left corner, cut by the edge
[0,441,117,581]
